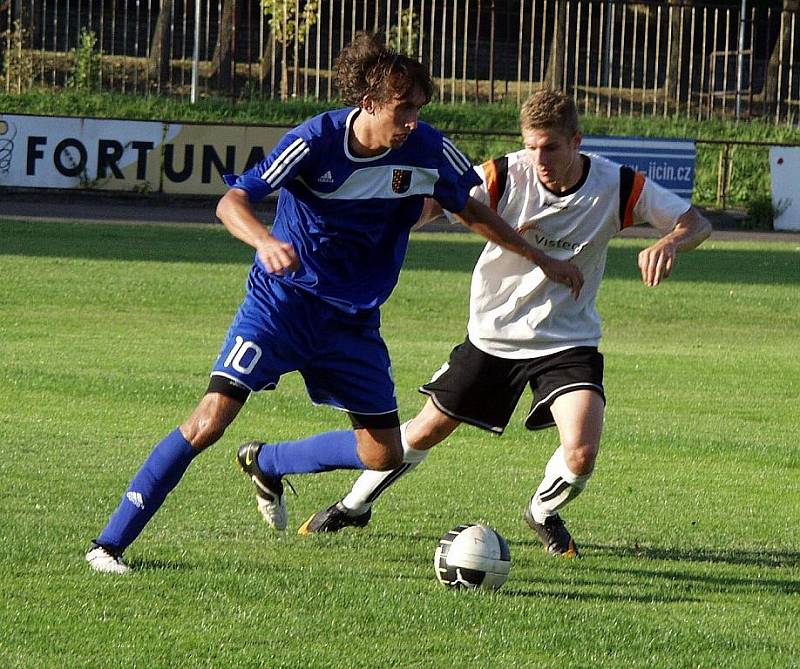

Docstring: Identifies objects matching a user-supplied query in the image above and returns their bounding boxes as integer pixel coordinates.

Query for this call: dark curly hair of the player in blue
[336,32,433,107]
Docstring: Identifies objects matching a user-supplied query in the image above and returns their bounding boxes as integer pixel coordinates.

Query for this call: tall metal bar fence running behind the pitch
[0,0,800,123]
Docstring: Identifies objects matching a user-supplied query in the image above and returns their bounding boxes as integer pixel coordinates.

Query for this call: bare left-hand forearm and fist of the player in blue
[217,188,299,274]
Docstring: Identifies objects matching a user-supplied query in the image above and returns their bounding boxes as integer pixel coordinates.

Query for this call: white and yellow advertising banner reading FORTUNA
[0,114,289,195]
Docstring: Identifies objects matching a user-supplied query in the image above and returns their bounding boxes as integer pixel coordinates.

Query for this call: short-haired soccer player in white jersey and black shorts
[299,90,711,557]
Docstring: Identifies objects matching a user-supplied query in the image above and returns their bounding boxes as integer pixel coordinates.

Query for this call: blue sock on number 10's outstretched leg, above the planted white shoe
[97,429,199,552]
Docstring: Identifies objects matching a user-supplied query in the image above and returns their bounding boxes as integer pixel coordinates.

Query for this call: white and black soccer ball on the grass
[433,525,511,590]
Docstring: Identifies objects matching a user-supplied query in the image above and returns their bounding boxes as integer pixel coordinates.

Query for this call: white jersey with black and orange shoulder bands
[468,150,690,359]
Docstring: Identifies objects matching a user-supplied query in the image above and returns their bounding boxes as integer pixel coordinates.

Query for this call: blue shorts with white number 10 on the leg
[211,267,397,415]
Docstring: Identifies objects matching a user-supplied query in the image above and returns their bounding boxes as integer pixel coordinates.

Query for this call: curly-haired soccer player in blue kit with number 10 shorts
[86,33,583,574]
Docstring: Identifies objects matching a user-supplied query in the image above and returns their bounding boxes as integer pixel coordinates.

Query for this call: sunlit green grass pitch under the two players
[0,221,800,669]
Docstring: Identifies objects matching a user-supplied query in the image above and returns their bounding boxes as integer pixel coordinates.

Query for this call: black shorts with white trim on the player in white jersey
[419,339,605,434]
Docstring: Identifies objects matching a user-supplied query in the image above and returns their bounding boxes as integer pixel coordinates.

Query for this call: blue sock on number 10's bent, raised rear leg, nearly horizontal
[258,430,365,476]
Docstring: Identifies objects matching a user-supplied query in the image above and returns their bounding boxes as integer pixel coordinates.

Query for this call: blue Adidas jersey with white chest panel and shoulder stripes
[225,109,480,313]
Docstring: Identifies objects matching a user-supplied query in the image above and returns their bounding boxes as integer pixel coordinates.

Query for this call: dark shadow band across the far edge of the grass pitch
[0,221,800,285]
